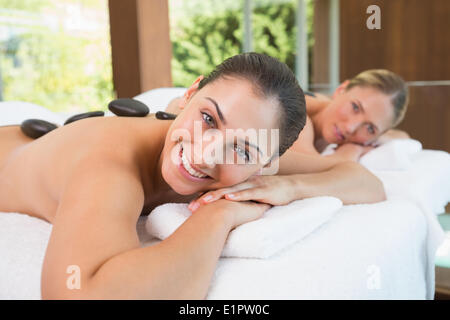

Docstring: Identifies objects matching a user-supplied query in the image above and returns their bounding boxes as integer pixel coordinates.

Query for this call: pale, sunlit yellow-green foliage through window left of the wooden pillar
[0,0,114,112]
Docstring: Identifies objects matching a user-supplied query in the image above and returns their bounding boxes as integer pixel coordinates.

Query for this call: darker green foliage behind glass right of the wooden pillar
[169,0,313,87]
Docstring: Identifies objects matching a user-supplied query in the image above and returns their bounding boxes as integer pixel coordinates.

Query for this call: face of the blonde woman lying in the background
[321,85,394,145]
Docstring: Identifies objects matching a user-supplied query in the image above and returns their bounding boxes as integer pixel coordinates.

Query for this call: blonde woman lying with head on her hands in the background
[290,69,409,161]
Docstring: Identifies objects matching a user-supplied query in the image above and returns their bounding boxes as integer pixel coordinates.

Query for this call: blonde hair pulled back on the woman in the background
[347,69,409,127]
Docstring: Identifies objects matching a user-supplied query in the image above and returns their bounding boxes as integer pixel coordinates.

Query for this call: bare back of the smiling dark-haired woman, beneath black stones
[0,117,192,222]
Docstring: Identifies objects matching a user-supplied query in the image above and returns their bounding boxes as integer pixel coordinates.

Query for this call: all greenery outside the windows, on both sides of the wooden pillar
[0,0,313,112]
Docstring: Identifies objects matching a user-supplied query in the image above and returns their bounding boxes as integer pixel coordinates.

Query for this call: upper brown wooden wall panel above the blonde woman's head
[340,0,450,81]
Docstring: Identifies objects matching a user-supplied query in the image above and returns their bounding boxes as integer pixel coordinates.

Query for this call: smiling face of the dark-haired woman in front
[162,78,279,195]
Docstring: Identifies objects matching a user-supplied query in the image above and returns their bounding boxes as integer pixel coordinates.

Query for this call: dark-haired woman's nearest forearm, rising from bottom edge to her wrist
[85,207,232,299]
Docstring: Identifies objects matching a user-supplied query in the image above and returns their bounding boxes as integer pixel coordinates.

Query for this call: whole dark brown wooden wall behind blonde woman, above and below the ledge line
[340,0,450,152]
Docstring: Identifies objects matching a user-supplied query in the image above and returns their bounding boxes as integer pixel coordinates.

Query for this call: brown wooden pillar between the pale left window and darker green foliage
[109,0,172,98]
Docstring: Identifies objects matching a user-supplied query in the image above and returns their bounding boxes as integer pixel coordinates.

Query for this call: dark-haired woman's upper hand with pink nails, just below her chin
[189,175,295,212]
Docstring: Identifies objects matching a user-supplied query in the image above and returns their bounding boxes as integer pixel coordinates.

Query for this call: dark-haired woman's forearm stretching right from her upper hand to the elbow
[289,162,386,204]
